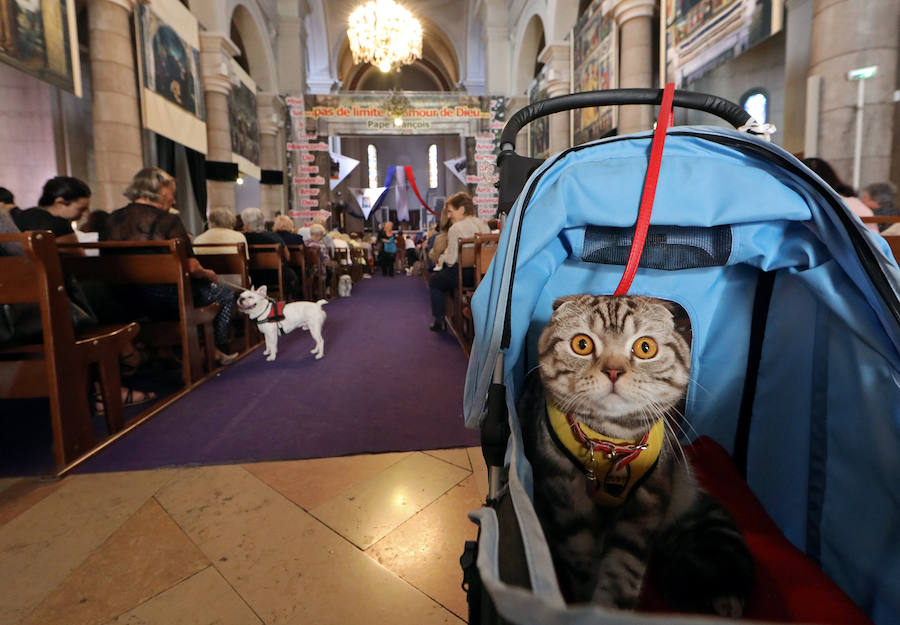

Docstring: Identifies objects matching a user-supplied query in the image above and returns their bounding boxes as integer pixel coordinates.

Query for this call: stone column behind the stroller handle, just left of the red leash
[613,0,656,135]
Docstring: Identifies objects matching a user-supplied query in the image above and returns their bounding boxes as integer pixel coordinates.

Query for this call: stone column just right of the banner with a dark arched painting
[200,33,239,212]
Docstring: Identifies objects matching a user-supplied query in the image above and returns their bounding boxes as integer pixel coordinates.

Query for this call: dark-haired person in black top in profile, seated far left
[13,176,91,243]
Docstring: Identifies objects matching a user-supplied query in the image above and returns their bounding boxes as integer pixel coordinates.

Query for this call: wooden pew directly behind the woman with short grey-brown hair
[59,239,219,387]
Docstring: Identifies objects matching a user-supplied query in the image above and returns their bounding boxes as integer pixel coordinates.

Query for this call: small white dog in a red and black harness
[237,285,328,360]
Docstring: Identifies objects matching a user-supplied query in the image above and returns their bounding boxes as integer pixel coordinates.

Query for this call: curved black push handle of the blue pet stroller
[500,89,750,152]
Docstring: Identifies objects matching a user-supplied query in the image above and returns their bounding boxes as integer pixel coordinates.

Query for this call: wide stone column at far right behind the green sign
[809,0,900,187]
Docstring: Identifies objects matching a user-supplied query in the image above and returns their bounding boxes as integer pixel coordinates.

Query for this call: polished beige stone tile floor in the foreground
[0,448,487,625]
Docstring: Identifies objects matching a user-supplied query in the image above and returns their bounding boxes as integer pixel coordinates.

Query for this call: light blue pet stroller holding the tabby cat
[461,89,900,625]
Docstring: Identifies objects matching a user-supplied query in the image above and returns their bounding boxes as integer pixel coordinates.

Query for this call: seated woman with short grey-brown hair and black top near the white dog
[100,167,238,365]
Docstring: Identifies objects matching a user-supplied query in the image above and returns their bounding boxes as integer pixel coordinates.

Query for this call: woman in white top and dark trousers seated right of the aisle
[428,191,491,332]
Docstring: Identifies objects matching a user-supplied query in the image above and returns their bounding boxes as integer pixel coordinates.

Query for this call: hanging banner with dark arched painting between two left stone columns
[134,0,207,154]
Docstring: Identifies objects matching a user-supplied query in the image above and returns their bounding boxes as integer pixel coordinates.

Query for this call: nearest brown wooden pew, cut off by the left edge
[0,231,139,469]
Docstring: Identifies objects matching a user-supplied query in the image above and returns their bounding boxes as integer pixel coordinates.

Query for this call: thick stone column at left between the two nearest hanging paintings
[88,0,144,211]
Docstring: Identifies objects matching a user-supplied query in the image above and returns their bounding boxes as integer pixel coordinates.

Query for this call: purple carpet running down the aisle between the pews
[79,275,478,472]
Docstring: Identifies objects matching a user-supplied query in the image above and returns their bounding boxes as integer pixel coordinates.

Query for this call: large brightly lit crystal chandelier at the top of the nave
[347,0,422,72]
